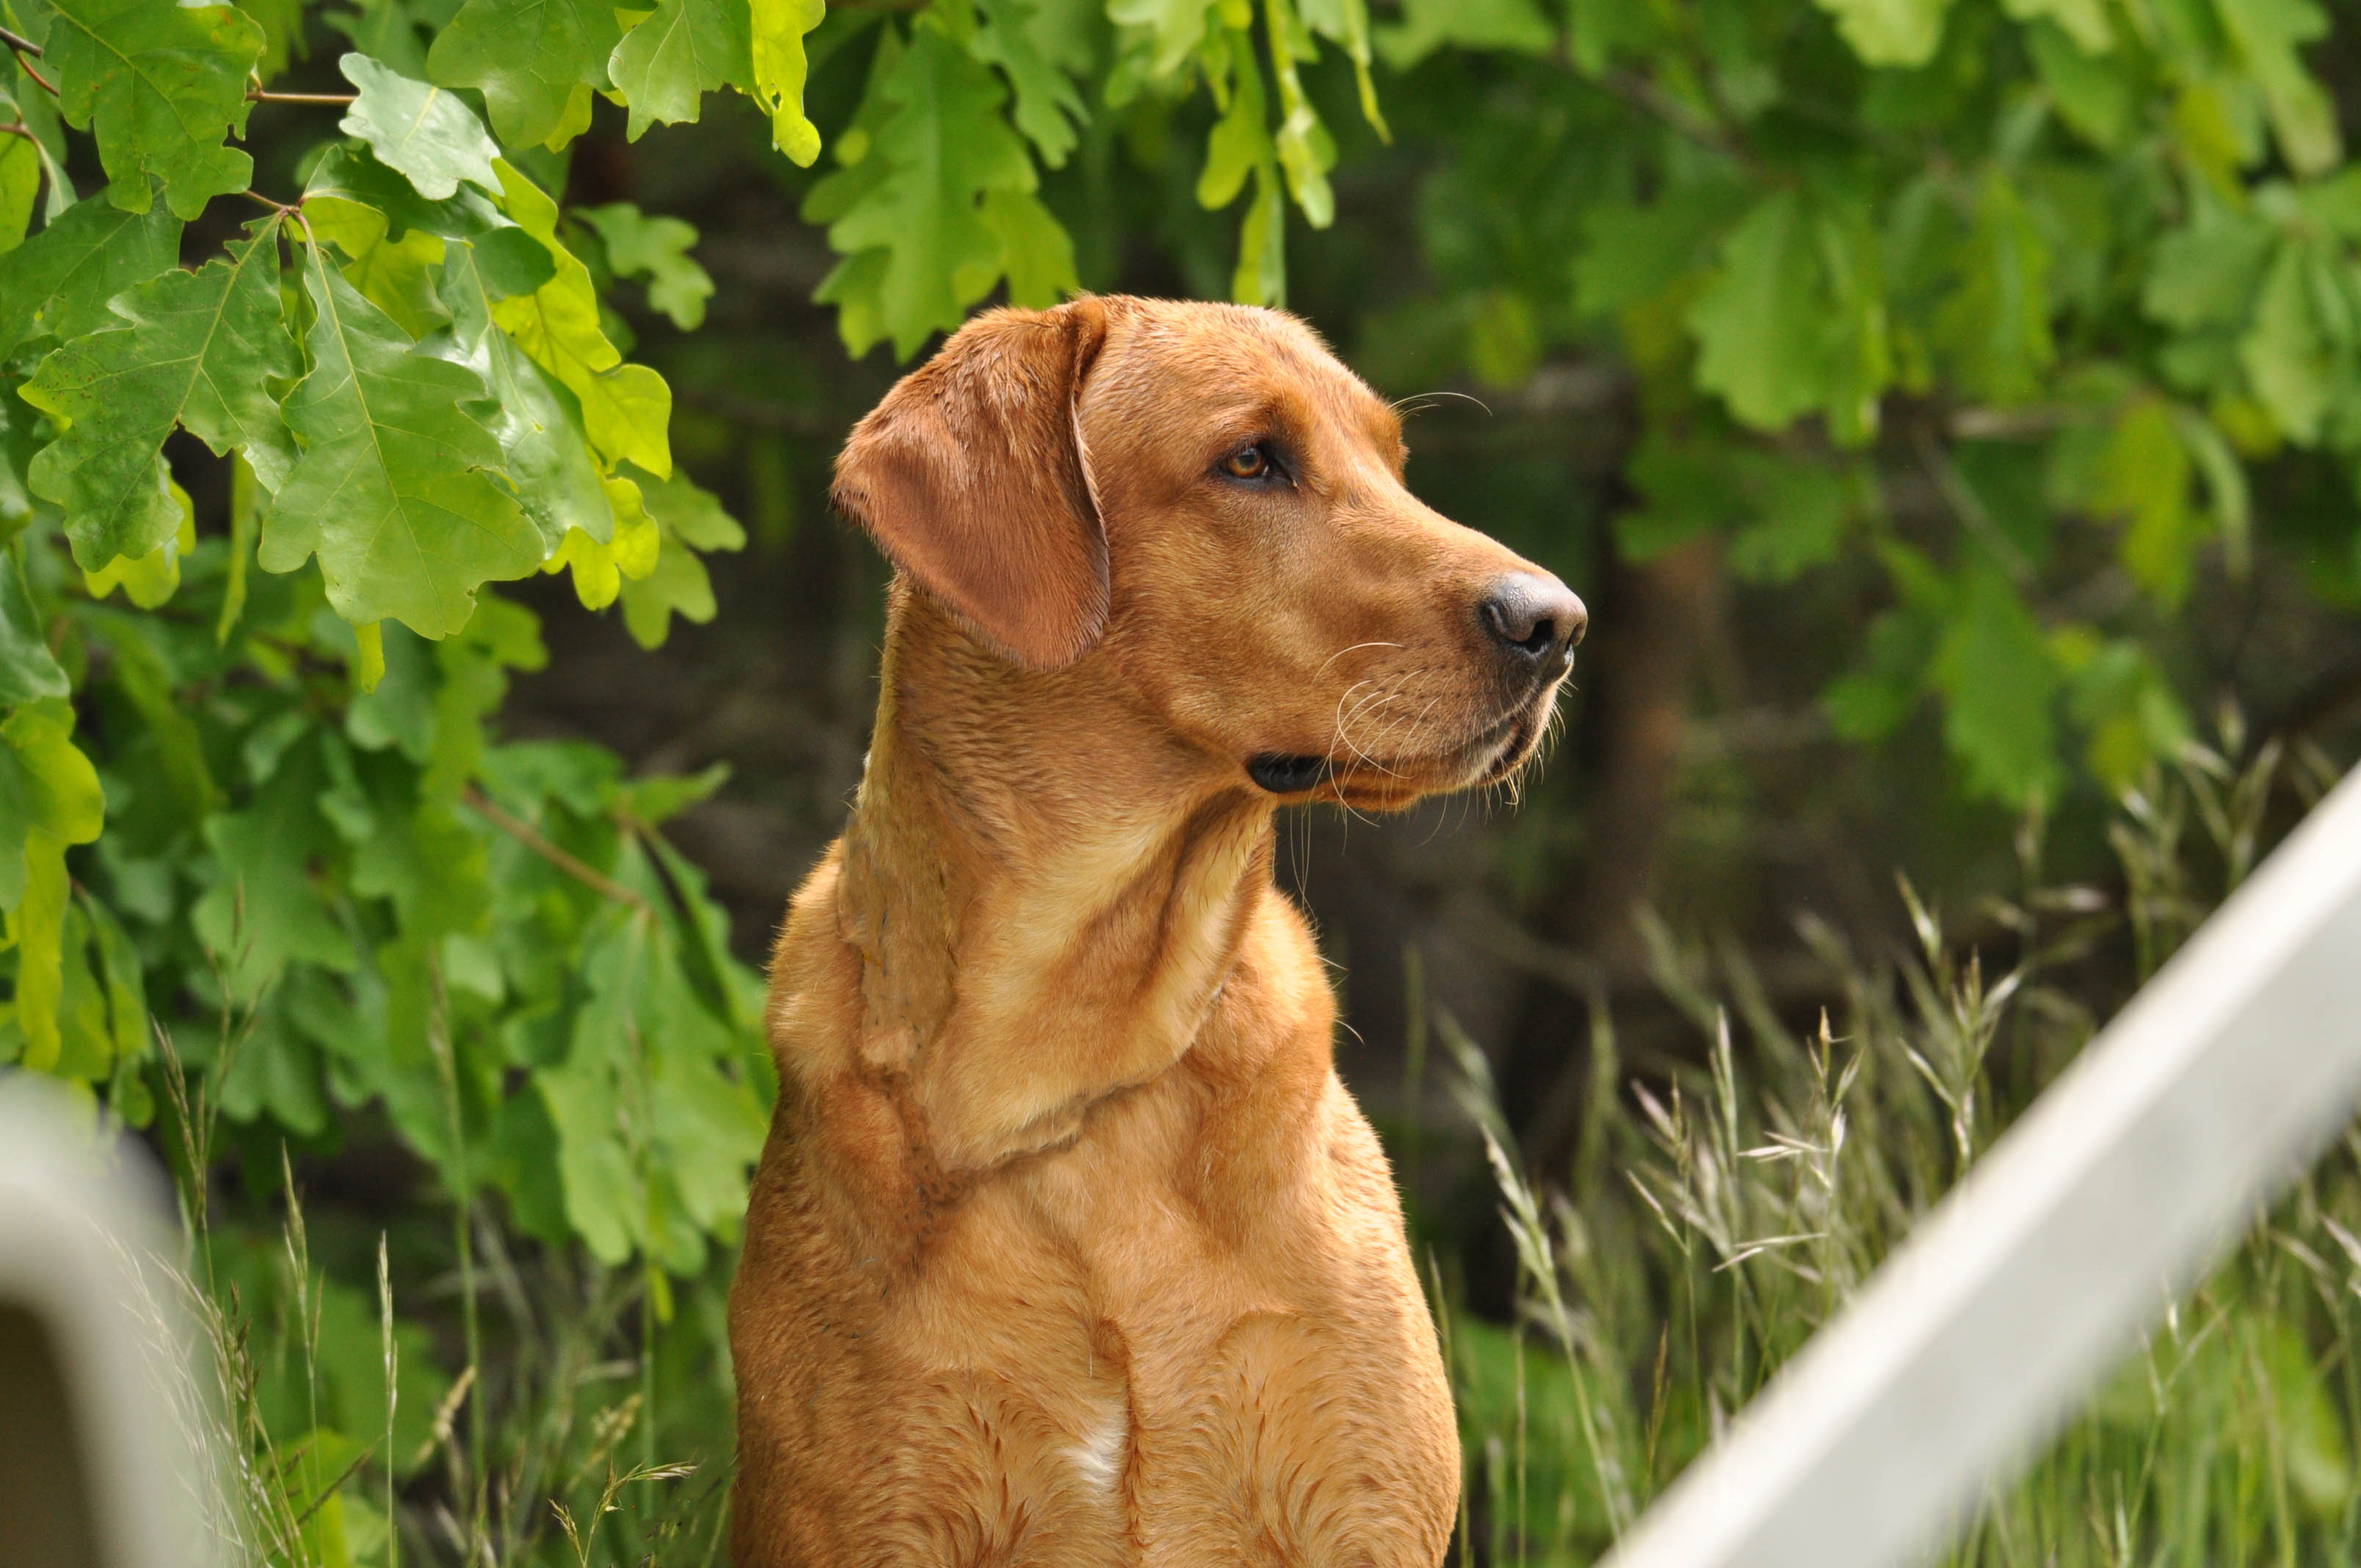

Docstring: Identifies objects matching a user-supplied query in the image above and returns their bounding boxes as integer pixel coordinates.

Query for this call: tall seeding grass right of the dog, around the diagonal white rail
[1438,736,2361,1568]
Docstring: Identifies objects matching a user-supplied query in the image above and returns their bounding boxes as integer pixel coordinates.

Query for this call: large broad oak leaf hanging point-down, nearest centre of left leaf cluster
[258,248,540,638]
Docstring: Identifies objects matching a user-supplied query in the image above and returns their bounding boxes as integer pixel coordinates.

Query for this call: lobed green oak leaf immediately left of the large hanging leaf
[21,219,302,571]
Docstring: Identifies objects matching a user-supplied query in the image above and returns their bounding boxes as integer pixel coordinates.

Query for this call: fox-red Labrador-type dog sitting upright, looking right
[730,297,1584,1568]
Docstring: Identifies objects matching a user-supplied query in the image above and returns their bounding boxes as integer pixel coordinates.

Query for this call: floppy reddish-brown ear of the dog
[833,300,1107,671]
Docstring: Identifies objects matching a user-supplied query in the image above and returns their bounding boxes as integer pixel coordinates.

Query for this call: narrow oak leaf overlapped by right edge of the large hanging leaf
[418,246,614,557]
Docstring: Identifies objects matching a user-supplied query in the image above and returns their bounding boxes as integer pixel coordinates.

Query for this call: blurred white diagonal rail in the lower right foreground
[1606,770,2361,1568]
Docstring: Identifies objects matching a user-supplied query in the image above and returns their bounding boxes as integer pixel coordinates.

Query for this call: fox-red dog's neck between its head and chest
[838,592,1272,1172]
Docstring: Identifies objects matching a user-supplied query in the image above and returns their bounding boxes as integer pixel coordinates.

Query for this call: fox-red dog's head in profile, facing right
[835,297,1584,807]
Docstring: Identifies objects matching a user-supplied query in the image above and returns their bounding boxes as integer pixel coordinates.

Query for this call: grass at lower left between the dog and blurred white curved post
[142,968,732,1568]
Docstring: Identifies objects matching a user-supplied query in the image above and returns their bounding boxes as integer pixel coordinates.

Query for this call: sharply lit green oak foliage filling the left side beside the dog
[0,0,774,1407]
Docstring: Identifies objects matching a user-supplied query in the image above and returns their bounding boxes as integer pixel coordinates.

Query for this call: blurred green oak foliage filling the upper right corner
[1360,0,2361,810]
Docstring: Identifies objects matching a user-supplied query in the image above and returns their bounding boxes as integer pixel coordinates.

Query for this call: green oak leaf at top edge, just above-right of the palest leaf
[427,0,623,146]
